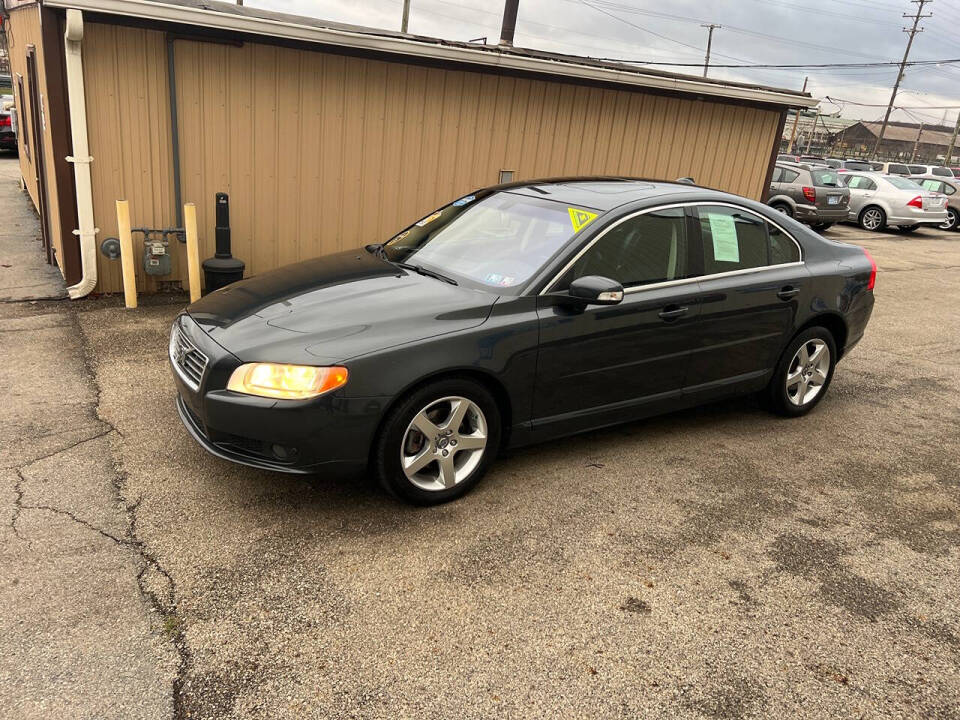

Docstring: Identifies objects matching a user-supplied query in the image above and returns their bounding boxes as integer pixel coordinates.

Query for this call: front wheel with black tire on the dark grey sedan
[371,378,501,505]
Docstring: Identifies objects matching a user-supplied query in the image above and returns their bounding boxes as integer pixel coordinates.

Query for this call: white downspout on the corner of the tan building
[63,10,99,300]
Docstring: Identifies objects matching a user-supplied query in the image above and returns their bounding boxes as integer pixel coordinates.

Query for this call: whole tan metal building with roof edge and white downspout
[4,0,816,297]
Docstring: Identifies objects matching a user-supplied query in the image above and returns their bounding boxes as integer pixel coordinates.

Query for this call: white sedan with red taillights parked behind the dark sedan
[840,172,947,232]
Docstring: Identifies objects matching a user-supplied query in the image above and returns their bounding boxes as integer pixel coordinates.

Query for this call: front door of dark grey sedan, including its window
[533,207,700,435]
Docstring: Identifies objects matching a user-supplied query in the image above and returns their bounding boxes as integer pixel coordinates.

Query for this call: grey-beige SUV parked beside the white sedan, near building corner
[767,162,850,230]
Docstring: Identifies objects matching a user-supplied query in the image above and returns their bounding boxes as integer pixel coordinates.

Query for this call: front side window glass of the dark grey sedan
[554,208,689,290]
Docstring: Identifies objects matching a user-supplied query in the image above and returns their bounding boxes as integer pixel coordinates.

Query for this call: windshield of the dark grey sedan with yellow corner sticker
[384,192,598,295]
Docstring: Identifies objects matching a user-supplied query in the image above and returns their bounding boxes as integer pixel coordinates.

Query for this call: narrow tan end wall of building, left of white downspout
[7,6,63,273]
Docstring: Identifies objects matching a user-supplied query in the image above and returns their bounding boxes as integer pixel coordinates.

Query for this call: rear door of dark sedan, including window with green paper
[686,204,812,395]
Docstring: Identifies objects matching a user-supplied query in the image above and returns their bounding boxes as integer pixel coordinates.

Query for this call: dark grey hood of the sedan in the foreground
[187,250,498,364]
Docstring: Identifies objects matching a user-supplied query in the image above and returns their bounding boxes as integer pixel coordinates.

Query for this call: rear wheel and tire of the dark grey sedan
[766,326,837,417]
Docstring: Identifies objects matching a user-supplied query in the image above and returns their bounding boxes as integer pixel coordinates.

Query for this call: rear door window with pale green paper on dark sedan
[697,205,769,275]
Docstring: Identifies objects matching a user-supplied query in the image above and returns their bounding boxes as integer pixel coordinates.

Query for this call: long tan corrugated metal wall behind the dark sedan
[84,24,779,291]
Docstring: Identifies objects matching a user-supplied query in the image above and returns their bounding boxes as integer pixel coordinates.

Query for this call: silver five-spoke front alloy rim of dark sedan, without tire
[400,397,487,492]
